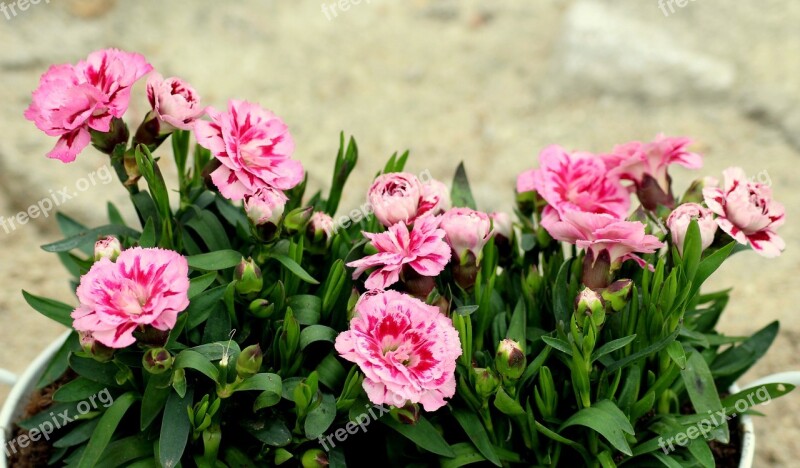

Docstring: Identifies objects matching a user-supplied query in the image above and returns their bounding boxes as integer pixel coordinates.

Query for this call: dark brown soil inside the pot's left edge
[8,372,75,468]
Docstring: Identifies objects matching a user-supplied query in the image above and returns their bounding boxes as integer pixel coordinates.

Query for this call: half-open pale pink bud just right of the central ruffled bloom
[440,208,492,263]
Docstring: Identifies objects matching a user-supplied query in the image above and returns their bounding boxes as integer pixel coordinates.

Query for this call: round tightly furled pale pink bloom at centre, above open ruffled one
[367,172,423,227]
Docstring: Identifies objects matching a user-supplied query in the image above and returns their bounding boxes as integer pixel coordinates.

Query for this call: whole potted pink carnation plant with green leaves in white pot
[0,49,797,467]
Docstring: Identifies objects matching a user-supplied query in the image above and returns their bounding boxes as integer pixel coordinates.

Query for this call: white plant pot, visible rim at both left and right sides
[0,332,800,468]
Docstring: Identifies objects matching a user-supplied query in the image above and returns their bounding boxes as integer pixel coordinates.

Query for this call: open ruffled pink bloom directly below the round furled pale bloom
[347,216,450,289]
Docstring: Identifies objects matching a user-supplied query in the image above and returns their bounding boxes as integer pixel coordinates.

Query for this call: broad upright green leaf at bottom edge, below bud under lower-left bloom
[158,388,194,468]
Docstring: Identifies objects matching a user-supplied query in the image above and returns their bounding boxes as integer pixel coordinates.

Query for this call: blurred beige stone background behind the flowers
[0,0,800,466]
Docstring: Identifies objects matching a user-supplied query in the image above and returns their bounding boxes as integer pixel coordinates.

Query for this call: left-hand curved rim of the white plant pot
[0,331,71,468]
